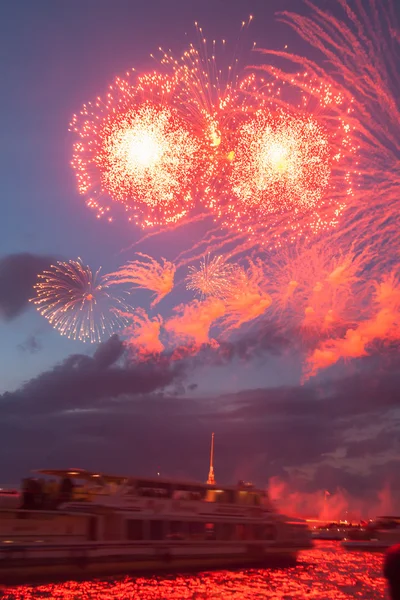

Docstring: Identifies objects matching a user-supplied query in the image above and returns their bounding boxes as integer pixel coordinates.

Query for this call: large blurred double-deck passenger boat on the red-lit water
[0,436,312,584]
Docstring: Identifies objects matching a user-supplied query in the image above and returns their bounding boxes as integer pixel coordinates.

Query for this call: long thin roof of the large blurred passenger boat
[34,469,263,493]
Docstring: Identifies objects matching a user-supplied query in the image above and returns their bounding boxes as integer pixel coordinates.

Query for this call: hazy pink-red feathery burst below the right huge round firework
[263,241,369,340]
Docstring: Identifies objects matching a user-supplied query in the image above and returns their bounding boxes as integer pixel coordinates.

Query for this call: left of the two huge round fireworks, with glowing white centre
[71,74,204,227]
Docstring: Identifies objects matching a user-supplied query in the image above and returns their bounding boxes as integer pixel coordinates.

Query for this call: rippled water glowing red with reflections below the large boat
[0,543,387,600]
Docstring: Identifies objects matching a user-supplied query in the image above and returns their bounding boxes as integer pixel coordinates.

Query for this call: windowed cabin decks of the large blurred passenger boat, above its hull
[0,469,307,545]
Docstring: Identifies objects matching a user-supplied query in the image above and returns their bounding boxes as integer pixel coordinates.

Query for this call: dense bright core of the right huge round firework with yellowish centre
[222,111,331,225]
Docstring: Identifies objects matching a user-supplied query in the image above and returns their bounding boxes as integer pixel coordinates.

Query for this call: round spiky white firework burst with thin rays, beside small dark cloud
[31,258,128,343]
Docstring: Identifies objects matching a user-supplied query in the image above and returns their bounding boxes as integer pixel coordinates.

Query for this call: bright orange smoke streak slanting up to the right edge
[305,274,400,378]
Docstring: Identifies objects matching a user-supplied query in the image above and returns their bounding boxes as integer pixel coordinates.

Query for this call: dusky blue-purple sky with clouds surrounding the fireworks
[0,0,400,516]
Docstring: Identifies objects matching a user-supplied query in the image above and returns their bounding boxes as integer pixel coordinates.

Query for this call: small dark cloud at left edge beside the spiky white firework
[0,253,55,321]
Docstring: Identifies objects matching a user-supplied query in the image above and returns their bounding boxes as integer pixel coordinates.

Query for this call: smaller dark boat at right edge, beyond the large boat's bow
[342,516,400,552]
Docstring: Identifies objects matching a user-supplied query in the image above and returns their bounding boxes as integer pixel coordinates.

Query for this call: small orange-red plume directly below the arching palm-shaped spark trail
[121,308,164,360]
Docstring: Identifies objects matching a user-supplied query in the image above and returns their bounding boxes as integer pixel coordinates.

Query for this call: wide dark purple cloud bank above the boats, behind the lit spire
[0,336,400,494]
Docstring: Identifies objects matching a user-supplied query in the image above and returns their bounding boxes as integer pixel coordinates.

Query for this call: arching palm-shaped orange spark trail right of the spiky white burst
[108,252,176,307]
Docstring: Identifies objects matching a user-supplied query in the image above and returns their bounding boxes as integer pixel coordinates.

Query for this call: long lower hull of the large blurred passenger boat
[0,542,311,584]
